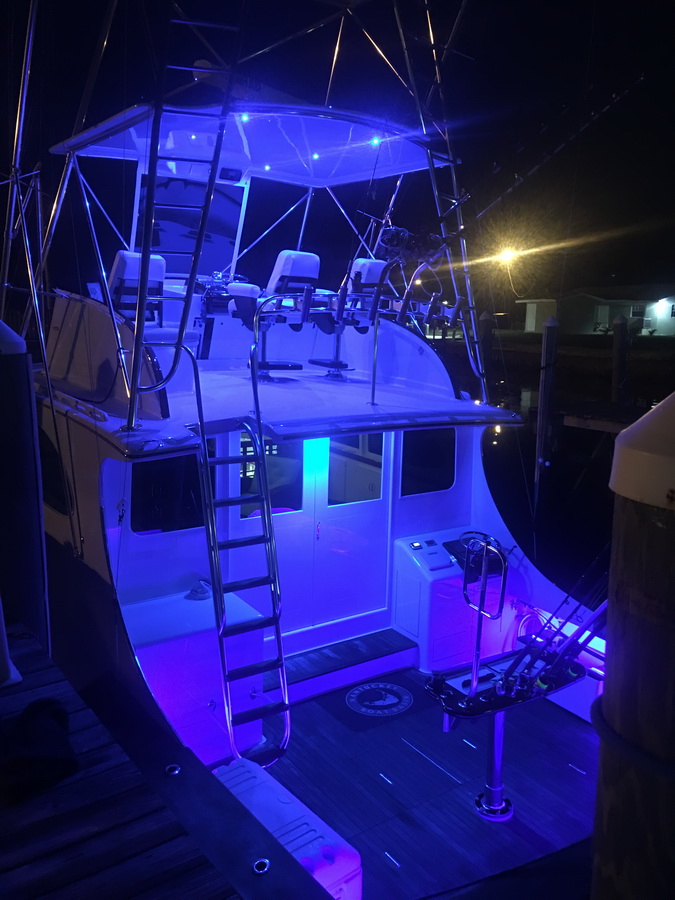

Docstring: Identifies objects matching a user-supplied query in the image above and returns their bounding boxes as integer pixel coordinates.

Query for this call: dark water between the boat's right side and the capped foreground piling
[439,341,624,605]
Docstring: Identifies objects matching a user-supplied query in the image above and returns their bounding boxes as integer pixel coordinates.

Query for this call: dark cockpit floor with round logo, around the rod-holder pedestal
[270,669,597,900]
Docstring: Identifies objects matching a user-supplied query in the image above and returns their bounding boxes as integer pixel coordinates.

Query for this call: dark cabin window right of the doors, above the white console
[401,428,455,497]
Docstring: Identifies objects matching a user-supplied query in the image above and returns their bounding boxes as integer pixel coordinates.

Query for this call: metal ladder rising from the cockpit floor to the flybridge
[186,351,291,767]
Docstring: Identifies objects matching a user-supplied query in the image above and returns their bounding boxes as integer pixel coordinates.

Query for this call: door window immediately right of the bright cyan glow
[328,432,382,506]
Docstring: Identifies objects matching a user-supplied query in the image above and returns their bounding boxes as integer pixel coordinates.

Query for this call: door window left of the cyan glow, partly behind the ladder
[240,432,303,519]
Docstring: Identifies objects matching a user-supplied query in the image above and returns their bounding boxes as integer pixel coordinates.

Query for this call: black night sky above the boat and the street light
[0,0,675,296]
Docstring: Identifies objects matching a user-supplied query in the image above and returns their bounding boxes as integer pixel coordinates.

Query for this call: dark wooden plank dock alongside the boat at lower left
[0,633,239,900]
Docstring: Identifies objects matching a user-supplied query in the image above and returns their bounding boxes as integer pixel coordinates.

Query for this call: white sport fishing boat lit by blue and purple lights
[3,4,603,900]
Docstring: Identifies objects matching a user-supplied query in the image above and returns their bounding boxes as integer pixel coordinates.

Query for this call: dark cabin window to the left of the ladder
[131,454,204,534]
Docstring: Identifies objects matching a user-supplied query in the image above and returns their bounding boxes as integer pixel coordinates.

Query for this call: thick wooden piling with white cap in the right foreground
[591,394,675,900]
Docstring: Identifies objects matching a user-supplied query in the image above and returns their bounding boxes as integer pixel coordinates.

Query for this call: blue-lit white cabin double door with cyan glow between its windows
[230,434,391,652]
